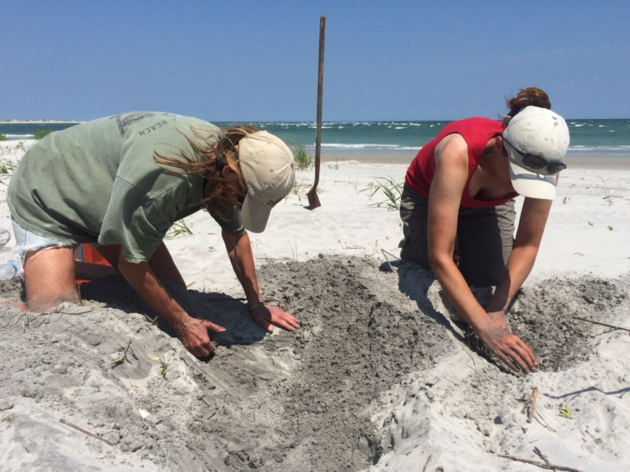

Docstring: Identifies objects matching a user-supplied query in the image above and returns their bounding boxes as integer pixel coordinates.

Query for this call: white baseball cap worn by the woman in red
[503,106,569,200]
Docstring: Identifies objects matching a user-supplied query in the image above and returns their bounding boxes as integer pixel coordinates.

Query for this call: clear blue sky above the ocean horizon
[0,0,630,121]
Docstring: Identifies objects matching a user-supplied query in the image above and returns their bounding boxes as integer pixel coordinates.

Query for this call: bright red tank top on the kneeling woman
[405,118,518,210]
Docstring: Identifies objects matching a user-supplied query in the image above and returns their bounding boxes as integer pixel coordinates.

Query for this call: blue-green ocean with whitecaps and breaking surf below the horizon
[0,119,630,157]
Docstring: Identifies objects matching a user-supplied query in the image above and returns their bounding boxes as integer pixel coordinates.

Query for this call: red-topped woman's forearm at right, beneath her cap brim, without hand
[487,246,538,313]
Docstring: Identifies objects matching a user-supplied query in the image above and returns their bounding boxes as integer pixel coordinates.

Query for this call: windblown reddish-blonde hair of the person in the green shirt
[153,125,258,218]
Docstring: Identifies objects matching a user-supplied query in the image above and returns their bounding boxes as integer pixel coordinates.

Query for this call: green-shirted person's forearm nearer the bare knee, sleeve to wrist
[118,257,189,331]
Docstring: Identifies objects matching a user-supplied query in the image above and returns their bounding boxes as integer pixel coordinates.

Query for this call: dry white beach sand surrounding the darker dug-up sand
[0,138,630,471]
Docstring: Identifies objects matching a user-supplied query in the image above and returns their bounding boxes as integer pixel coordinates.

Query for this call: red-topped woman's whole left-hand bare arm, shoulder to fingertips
[428,134,536,372]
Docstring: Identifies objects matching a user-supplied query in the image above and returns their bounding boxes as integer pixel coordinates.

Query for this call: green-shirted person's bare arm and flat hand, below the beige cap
[222,231,300,332]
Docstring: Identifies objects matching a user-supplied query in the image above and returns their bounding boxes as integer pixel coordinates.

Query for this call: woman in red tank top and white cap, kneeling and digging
[400,88,569,372]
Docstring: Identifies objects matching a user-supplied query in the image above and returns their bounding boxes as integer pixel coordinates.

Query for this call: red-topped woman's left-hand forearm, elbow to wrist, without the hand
[431,255,491,331]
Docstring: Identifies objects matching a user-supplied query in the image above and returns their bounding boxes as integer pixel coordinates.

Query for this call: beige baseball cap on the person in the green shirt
[238,131,295,233]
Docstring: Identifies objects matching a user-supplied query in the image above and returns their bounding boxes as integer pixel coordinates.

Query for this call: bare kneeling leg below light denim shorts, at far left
[24,247,81,313]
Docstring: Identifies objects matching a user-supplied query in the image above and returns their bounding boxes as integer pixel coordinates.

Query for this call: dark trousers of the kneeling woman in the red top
[399,185,516,287]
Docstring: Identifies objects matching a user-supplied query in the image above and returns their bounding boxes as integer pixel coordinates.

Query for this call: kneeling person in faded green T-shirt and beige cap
[7,112,299,357]
